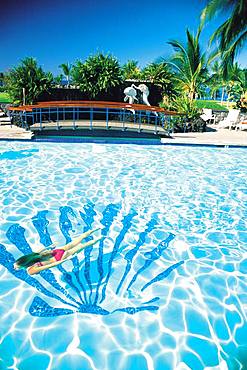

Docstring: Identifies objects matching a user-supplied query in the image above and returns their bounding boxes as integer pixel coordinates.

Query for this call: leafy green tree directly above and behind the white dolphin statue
[142,62,176,98]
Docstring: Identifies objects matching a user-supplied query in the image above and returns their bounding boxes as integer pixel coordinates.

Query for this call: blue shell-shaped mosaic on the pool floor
[0,202,184,317]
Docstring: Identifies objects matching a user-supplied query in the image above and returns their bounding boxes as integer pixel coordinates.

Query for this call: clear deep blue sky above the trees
[0,0,247,74]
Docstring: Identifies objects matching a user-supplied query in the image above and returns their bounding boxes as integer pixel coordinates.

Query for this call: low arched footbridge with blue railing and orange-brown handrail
[9,101,183,137]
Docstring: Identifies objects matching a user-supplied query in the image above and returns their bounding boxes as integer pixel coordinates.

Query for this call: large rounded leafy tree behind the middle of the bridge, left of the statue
[72,53,122,99]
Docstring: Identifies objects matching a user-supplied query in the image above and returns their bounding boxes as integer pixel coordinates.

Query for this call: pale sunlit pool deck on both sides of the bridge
[0,124,247,147]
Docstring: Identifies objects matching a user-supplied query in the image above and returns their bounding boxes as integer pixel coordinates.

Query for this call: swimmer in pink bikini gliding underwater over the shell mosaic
[14,229,102,275]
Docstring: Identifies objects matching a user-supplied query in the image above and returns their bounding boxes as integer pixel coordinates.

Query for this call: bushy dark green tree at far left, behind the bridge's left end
[5,58,53,104]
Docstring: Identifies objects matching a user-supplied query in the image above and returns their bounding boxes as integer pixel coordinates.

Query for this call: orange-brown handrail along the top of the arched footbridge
[8,100,181,116]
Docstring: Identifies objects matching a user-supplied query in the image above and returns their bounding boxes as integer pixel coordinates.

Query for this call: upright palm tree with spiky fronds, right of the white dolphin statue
[168,28,208,100]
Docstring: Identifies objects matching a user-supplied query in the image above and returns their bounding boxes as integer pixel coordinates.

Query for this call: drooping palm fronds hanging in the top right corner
[201,0,247,77]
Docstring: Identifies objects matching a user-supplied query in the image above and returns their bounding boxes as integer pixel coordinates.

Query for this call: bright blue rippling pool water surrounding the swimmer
[0,142,247,370]
